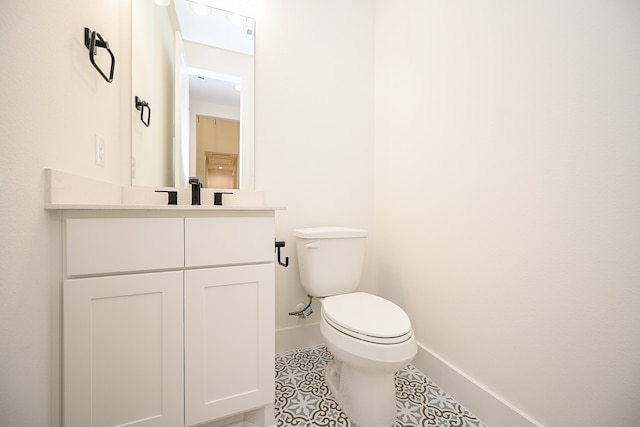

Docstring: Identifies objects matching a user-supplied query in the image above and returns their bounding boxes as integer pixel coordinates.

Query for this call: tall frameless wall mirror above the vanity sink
[131,0,256,189]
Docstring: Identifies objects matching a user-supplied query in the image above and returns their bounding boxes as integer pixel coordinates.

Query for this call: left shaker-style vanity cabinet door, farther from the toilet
[63,271,184,427]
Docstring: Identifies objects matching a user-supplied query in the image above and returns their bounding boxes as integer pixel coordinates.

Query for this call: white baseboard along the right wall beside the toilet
[411,343,544,427]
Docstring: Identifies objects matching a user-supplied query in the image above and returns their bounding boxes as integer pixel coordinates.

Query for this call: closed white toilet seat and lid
[322,292,413,344]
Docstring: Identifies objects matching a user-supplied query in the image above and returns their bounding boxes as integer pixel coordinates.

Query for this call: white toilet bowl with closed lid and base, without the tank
[320,293,417,427]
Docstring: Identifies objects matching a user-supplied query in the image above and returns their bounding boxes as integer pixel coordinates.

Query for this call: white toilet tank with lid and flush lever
[293,227,368,297]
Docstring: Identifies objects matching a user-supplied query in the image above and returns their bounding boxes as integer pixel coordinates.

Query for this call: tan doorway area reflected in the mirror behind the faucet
[196,115,240,188]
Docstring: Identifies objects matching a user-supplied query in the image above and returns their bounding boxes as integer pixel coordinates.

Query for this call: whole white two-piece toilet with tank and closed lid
[294,227,417,427]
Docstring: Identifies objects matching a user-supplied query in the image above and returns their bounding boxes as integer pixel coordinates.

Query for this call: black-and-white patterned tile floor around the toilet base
[275,345,486,427]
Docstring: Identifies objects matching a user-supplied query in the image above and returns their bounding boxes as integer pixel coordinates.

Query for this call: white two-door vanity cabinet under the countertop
[61,209,275,427]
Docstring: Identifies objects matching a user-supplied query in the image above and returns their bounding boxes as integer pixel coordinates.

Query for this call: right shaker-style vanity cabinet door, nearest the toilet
[184,263,275,426]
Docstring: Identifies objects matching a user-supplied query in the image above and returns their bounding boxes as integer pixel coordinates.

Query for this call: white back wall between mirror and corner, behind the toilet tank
[255,0,374,329]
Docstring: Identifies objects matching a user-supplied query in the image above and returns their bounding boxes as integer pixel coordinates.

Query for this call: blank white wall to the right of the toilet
[374,0,640,427]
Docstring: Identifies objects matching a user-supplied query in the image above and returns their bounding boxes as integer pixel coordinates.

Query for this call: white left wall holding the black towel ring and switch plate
[0,0,133,427]
